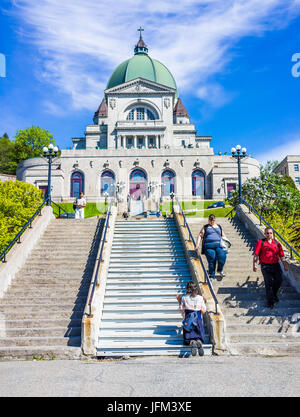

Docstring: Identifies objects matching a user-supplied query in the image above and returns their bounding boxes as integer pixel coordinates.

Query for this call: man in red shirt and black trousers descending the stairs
[253,227,288,308]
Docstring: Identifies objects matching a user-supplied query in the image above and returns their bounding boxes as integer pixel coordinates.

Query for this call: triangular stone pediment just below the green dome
[105,78,176,95]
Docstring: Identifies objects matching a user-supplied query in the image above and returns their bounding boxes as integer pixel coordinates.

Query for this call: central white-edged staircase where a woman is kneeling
[97,219,211,357]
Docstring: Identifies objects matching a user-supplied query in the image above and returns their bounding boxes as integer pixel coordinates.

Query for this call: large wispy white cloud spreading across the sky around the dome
[7,0,300,110]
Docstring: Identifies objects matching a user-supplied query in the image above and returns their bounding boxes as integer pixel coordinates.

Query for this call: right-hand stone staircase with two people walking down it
[188,214,300,356]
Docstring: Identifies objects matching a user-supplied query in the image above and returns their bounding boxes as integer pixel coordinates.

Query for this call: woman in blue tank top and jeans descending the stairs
[195,214,226,278]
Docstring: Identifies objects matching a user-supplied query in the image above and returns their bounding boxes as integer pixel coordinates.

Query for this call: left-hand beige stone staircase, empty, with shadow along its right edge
[0,218,103,360]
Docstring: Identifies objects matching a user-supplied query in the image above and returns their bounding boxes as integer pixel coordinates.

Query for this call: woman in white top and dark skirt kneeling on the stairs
[176,281,206,356]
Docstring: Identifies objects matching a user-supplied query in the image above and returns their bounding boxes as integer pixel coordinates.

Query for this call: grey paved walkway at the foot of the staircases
[0,356,300,398]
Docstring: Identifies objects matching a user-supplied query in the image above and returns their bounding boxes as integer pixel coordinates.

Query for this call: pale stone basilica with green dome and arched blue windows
[17,31,259,206]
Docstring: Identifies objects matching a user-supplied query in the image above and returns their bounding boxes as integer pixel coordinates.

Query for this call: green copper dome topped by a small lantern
[106,32,177,97]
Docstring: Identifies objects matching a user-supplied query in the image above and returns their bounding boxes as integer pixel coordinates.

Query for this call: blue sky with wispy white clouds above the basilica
[0,0,300,162]
